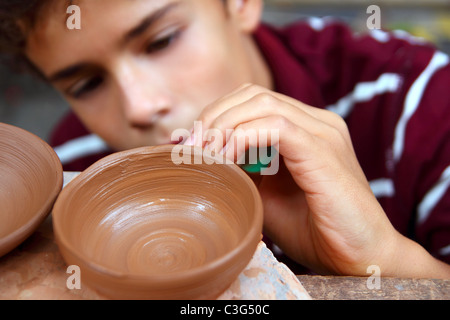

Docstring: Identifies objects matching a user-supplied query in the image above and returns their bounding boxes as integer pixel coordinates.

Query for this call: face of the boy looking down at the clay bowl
[27,0,268,150]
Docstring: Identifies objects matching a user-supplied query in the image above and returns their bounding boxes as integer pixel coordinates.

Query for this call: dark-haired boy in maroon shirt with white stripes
[0,0,450,278]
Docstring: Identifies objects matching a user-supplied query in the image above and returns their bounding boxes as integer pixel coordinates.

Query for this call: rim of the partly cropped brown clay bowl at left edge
[0,123,64,256]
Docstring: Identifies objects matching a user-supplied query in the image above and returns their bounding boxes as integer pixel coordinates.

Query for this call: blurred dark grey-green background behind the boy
[0,0,450,141]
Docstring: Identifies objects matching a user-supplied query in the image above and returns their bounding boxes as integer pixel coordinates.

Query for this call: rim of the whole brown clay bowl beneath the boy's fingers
[53,145,263,286]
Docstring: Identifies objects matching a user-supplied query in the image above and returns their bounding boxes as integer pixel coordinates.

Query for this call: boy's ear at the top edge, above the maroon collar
[226,0,264,33]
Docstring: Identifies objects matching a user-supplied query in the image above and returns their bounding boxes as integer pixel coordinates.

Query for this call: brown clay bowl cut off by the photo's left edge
[0,123,63,256]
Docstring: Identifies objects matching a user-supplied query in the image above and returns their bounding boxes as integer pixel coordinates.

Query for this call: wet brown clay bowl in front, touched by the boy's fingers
[53,145,263,300]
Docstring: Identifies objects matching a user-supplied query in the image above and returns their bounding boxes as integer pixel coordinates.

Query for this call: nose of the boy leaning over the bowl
[117,64,171,129]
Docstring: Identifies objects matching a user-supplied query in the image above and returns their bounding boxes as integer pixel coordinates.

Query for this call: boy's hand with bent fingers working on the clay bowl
[184,85,450,276]
